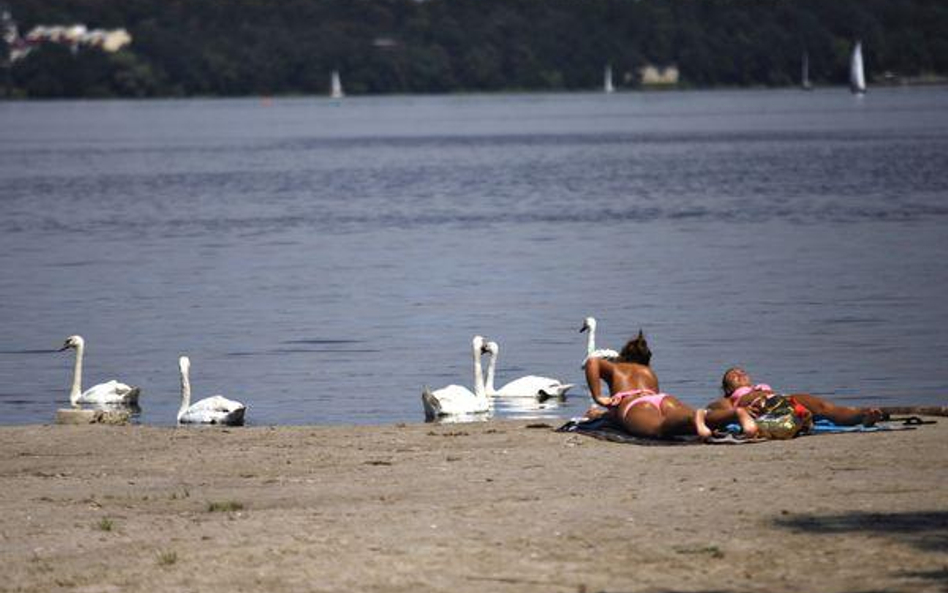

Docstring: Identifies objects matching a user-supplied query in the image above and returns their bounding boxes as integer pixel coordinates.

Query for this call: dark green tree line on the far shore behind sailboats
[0,0,948,97]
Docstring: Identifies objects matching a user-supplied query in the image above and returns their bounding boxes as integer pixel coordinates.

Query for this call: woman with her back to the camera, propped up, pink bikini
[586,331,753,438]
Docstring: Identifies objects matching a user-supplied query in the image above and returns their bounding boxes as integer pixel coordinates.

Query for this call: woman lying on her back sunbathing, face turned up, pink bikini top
[698,367,883,426]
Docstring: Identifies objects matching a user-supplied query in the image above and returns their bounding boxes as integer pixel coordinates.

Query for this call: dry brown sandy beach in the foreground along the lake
[0,418,948,593]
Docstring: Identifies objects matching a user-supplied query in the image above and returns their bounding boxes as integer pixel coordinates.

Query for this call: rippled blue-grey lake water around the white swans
[0,88,948,425]
